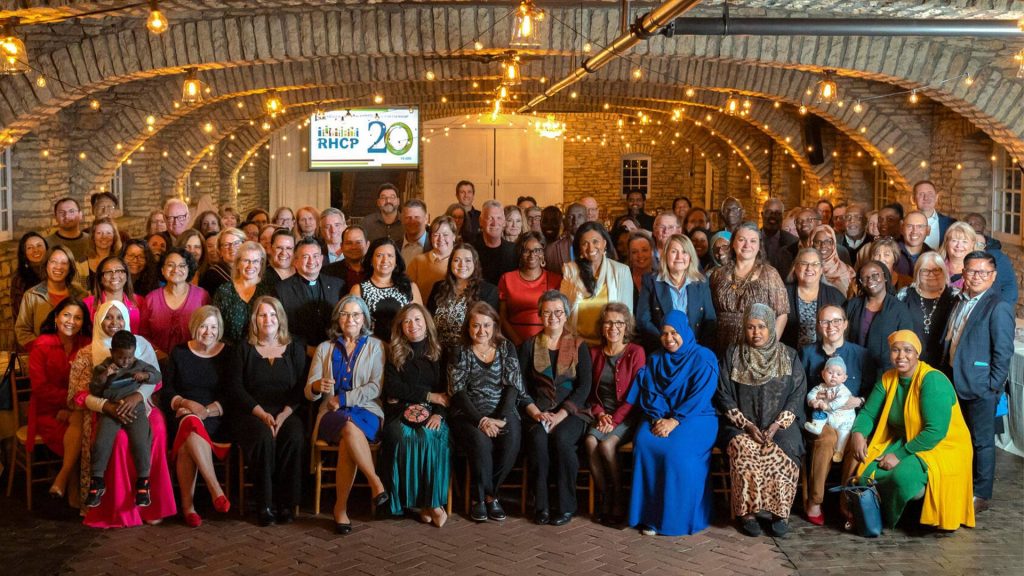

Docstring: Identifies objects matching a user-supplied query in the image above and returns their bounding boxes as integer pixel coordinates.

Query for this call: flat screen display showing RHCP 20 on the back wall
[309,108,420,170]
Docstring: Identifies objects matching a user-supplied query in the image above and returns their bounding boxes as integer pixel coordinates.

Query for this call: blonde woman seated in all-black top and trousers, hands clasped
[231,295,306,526]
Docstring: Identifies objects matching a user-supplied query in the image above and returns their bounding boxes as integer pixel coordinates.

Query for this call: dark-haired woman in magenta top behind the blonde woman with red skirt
[138,248,210,358]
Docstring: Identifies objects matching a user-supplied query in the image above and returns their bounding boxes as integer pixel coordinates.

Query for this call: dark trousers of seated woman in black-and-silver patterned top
[451,417,522,502]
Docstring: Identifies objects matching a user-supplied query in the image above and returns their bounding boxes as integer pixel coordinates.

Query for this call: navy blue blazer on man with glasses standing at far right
[942,286,1015,400]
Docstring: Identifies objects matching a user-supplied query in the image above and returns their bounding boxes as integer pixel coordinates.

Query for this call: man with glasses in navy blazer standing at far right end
[943,250,1014,511]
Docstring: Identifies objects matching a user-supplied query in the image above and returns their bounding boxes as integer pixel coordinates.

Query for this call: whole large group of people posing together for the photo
[12,177,1017,536]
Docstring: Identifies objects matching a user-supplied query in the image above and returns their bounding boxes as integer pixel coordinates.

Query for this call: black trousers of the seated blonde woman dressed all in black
[231,414,304,509]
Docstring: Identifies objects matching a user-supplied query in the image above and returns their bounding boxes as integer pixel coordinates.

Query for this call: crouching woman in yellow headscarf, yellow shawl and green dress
[849,330,974,530]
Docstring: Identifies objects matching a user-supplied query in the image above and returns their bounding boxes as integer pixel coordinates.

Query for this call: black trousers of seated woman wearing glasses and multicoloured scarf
[526,415,587,513]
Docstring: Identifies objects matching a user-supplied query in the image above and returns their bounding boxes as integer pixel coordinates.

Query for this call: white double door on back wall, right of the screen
[422,116,562,217]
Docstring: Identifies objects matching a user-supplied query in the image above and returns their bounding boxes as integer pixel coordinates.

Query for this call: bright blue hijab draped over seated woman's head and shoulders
[630,311,718,419]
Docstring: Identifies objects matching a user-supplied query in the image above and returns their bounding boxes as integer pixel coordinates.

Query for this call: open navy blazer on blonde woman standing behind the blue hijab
[636,273,718,354]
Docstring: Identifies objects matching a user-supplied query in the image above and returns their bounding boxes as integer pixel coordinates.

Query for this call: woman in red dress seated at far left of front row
[25,298,92,498]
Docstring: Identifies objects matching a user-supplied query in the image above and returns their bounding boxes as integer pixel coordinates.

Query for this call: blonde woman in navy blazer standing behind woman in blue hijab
[637,234,718,353]
